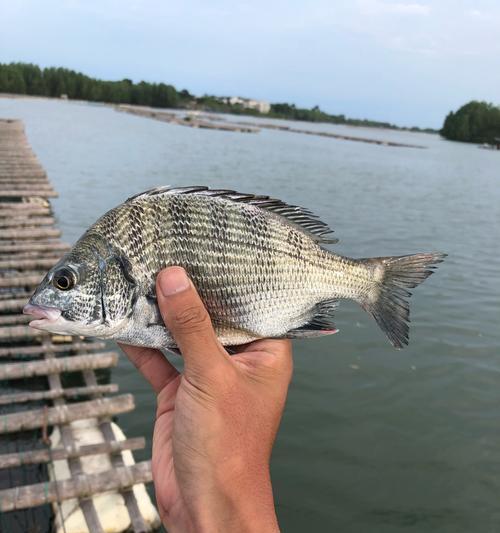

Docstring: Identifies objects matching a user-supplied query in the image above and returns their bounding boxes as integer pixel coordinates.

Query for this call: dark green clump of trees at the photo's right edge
[440,101,500,144]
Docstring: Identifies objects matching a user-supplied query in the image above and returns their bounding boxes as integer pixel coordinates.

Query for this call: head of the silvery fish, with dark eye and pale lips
[23,236,136,338]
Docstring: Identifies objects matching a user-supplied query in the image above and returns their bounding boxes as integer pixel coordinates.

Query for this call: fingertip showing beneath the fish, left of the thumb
[118,343,179,394]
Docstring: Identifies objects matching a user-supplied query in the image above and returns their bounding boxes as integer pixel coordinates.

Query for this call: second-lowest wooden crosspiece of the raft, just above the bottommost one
[0,437,146,468]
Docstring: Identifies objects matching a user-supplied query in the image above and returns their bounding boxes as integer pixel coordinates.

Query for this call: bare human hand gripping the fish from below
[122,267,293,533]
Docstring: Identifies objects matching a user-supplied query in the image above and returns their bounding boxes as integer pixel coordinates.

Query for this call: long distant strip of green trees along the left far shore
[0,63,434,131]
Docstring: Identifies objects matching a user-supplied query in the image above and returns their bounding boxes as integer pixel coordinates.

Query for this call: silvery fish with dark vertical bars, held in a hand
[23,186,446,350]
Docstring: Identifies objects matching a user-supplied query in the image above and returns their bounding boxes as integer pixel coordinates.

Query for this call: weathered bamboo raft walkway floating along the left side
[0,119,157,533]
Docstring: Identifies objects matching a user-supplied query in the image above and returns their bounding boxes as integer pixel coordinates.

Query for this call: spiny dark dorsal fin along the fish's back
[127,185,338,244]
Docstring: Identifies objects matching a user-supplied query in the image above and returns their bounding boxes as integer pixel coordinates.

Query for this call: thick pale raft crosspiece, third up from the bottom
[0,394,135,434]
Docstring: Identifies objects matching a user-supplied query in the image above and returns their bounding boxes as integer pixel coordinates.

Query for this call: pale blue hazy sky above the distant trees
[0,0,500,128]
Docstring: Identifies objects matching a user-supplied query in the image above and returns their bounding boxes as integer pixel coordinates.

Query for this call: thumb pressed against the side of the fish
[156,267,229,374]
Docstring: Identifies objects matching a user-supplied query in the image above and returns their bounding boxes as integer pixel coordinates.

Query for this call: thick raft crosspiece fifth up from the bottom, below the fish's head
[0,352,118,380]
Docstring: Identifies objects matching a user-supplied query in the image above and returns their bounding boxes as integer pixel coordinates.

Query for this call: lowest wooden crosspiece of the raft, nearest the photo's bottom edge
[0,461,153,513]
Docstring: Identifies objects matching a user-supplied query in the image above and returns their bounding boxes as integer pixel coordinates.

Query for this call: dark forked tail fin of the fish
[360,252,446,348]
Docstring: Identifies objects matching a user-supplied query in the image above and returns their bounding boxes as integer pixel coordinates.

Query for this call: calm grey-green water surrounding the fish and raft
[0,99,500,533]
